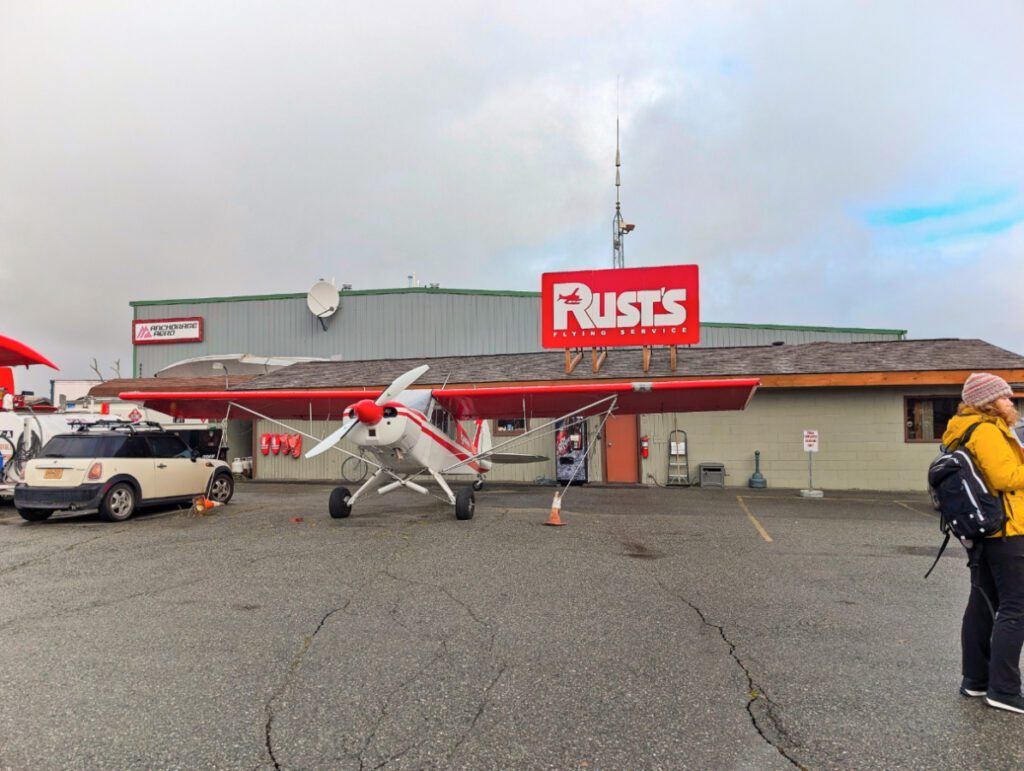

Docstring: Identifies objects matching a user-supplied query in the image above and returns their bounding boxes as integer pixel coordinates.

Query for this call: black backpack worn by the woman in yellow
[925,422,1007,579]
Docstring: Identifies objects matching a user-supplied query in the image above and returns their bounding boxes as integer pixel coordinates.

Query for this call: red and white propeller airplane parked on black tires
[121,365,759,519]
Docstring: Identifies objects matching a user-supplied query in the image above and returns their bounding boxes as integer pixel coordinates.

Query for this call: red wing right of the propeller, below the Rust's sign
[433,378,761,420]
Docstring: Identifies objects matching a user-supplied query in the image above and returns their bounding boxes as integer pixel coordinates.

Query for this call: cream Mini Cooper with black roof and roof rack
[14,422,234,522]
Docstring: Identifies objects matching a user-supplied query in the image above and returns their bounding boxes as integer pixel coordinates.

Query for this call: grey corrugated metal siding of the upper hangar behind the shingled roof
[134,292,895,377]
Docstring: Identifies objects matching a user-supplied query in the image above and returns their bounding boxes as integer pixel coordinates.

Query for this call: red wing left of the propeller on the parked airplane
[113,390,383,420]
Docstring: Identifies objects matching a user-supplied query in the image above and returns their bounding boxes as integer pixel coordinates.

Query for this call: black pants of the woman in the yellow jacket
[961,536,1024,696]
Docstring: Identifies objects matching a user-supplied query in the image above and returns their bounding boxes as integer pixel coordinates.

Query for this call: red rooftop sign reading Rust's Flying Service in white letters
[541,265,700,348]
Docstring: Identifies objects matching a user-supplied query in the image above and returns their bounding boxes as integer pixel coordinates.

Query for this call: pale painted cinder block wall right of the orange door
[640,387,959,491]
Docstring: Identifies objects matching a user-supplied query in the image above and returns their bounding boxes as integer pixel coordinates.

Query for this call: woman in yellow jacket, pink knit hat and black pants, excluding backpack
[942,373,1024,715]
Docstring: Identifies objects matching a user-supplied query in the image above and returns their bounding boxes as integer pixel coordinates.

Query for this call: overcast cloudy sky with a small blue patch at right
[0,0,1024,392]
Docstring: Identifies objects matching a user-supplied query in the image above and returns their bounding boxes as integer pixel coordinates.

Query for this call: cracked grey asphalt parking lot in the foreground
[0,483,1024,769]
